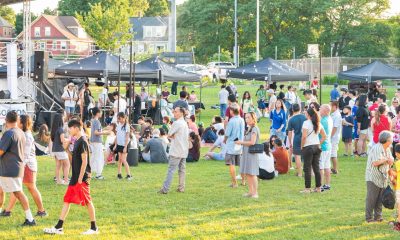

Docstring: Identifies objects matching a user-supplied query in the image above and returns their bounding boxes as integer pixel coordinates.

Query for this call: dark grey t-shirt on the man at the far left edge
[0,128,25,177]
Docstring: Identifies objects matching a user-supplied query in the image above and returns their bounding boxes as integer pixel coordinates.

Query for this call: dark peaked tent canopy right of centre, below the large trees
[227,58,310,82]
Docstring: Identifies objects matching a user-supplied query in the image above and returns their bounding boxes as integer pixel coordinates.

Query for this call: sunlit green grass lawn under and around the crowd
[0,85,400,240]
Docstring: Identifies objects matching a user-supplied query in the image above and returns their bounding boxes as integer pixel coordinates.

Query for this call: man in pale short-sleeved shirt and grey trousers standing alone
[158,107,189,194]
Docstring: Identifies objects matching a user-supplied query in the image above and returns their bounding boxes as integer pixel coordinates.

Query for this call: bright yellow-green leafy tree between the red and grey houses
[77,0,148,51]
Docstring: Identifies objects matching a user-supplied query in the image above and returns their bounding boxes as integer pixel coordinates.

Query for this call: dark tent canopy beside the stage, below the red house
[55,52,125,78]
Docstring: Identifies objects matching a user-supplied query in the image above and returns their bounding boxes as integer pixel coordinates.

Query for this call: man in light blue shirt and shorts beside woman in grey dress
[224,103,245,188]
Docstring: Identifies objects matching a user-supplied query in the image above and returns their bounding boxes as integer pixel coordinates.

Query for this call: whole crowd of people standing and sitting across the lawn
[0,79,400,234]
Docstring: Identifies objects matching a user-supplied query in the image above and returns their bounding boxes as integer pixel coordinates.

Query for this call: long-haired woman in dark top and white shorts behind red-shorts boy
[50,114,70,185]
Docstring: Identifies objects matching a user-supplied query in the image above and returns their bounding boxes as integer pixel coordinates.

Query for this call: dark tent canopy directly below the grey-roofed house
[108,57,201,83]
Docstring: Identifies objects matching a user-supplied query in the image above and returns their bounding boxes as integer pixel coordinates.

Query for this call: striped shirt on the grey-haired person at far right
[365,143,392,188]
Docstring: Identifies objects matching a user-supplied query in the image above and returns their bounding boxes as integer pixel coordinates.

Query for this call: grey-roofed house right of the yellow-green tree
[130,17,170,53]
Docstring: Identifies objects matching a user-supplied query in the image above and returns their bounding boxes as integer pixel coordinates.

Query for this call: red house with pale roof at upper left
[17,14,94,59]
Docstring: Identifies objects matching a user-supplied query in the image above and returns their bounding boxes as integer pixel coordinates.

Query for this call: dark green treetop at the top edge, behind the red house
[58,0,102,16]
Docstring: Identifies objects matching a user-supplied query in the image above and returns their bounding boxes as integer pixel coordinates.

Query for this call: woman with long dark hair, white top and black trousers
[300,108,326,193]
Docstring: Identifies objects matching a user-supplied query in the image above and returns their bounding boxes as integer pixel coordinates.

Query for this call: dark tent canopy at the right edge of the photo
[338,61,400,82]
